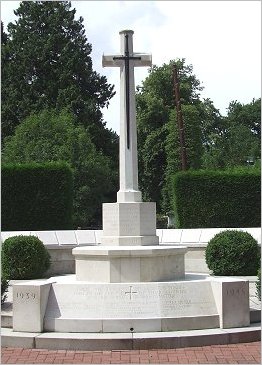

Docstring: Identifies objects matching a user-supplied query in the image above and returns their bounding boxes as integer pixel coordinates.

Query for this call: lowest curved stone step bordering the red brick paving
[1,324,261,351]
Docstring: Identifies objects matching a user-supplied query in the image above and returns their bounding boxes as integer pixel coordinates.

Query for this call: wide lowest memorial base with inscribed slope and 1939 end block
[13,275,250,333]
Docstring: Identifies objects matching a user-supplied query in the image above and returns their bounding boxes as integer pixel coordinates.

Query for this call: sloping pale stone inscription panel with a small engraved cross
[46,282,217,319]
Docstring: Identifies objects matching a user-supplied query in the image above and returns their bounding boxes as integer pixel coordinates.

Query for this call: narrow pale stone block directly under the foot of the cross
[101,202,159,246]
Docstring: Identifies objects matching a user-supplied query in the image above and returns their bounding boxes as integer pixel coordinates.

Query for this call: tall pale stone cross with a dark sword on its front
[102,30,152,202]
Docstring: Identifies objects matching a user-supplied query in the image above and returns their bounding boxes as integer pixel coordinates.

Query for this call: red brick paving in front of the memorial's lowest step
[2,342,261,364]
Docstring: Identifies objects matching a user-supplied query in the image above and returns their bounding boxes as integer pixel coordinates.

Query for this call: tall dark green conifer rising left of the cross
[2,1,117,159]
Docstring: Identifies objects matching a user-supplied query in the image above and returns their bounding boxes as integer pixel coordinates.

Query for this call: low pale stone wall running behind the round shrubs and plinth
[1,228,261,275]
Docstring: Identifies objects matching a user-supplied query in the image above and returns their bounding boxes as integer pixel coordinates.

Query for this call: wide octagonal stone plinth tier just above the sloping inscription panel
[72,246,187,283]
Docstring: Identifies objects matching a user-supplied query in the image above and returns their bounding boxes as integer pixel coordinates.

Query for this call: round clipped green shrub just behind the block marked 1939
[2,236,50,280]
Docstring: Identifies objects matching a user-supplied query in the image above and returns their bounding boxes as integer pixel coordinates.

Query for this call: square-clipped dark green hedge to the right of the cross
[172,169,261,228]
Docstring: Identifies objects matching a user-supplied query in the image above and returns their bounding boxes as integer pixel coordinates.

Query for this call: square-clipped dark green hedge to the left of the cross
[1,163,73,231]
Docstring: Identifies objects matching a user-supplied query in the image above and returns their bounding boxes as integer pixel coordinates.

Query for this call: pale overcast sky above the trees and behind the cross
[1,0,261,132]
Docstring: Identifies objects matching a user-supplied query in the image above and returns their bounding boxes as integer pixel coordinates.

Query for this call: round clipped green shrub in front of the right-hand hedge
[205,230,260,276]
